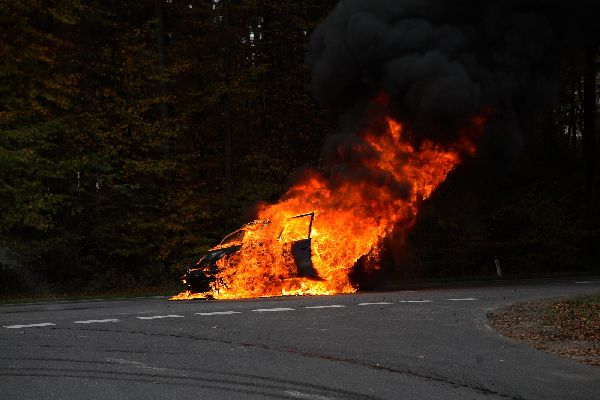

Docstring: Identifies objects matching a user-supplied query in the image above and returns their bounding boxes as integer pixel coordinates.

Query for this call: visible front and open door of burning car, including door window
[182,212,319,293]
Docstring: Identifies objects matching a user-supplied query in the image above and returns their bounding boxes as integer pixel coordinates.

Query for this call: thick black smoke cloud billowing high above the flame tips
[307,0,600,145]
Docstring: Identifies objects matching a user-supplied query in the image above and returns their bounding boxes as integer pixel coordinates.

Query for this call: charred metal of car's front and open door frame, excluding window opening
[182,212,319,293]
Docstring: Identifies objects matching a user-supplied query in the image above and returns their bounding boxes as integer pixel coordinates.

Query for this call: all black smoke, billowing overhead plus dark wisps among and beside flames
[307,0,600,287]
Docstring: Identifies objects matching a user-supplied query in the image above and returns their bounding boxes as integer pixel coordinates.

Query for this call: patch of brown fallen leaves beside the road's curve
[488,295,600,366]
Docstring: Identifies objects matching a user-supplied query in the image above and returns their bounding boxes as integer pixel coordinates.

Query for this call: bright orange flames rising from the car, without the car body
[173,109,485,299]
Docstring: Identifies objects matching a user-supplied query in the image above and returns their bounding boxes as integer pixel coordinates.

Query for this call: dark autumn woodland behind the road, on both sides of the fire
[0,0,600,293]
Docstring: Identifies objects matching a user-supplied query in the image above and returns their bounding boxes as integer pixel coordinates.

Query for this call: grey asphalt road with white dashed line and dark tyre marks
[0,281,600,400]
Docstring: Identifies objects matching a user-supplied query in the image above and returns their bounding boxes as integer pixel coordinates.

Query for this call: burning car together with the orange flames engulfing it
[172,114,486,300]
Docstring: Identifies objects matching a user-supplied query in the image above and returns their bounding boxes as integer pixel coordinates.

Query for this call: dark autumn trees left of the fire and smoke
[0,0,332,289]
